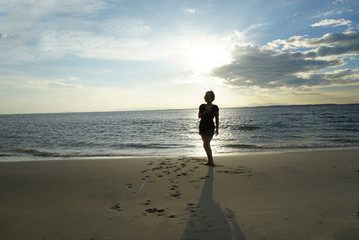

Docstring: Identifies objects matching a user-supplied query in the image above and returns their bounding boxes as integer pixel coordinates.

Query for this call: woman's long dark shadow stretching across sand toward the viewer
[181,167,245,240]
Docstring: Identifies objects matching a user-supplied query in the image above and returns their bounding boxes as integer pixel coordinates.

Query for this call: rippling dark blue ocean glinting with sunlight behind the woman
[0,104,359,162]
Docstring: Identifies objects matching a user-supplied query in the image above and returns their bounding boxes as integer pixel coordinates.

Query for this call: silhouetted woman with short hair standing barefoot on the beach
[198,91,219,167]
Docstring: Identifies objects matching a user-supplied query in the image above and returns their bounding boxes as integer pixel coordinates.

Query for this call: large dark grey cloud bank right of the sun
[211,32,359,89]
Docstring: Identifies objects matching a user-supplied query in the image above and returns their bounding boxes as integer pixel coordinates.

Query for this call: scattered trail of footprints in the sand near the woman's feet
[110,157,252,218]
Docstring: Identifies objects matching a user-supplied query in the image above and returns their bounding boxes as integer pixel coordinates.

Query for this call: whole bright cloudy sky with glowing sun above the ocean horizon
[0,0,359,114]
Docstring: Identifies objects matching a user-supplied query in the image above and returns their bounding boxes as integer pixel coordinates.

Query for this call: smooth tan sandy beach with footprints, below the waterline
[0,150,359,240]
